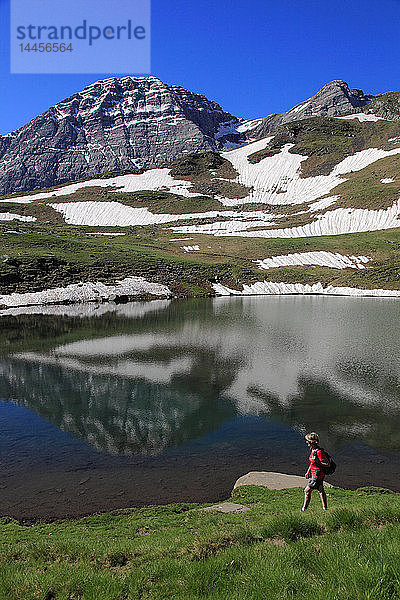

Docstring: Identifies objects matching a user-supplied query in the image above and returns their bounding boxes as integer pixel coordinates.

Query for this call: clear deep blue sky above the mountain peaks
[0,0,400,134]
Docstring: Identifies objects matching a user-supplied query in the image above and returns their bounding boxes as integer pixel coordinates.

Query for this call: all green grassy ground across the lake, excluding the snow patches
[0,135,400,296]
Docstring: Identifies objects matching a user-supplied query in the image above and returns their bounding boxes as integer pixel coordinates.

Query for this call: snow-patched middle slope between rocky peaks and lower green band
[0,117,400,239]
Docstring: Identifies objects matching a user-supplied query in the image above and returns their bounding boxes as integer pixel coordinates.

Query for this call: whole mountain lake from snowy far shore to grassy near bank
[0,296,400,519]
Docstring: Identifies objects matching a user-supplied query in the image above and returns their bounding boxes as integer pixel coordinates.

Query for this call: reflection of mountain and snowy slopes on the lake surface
[0,297,400,454]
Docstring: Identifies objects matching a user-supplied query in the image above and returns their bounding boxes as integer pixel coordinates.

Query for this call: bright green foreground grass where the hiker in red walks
[0,486,400,600]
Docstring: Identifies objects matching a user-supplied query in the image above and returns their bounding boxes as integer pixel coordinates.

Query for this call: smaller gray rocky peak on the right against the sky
[247,80,375,138]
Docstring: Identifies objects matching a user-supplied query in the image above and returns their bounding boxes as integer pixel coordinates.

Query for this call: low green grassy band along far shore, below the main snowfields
[0,224,400,296]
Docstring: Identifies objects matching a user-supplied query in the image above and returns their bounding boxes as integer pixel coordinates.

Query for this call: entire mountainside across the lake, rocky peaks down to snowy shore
[0,78,400,306]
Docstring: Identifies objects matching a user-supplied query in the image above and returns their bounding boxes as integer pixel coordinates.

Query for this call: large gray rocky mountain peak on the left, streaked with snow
[0,77,239,194]
